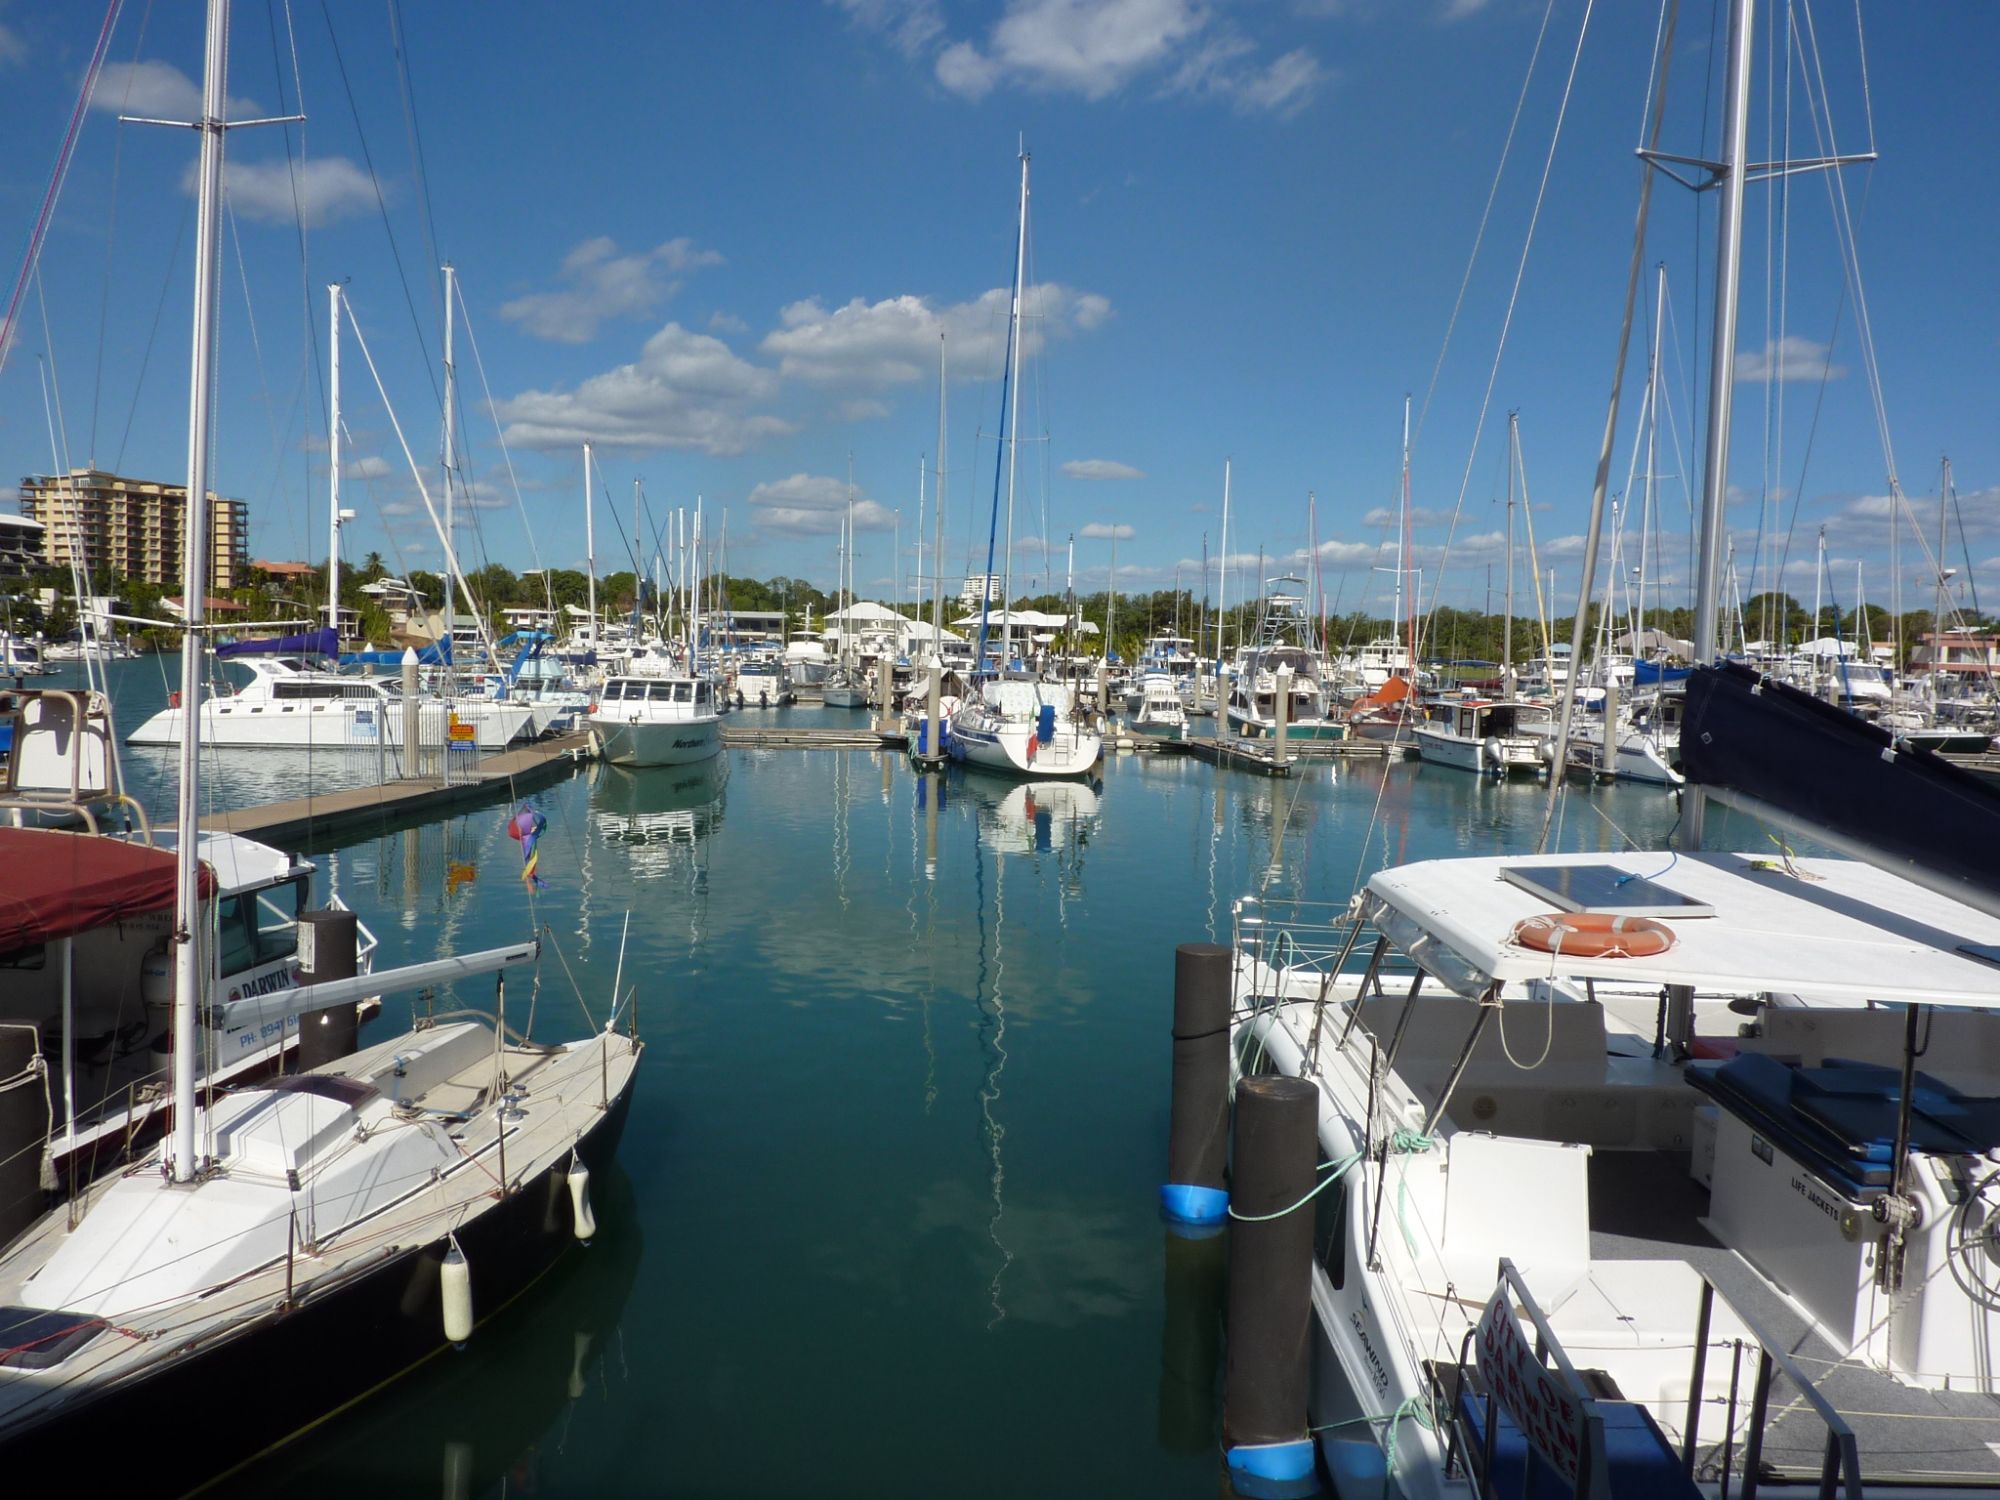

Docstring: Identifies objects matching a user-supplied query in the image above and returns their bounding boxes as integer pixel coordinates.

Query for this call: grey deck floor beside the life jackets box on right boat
[1590,1152,2000,1486]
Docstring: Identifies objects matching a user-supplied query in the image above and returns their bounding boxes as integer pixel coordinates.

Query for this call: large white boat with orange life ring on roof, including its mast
[1236,0,2000,1498]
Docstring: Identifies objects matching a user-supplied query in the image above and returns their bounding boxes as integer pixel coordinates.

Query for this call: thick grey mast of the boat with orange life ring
[1682,0,1756,848]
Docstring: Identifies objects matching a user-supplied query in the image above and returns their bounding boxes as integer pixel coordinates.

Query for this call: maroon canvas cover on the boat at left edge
[0,828,216,954]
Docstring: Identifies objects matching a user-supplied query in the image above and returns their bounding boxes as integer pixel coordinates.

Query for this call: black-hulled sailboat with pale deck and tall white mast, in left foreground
[0,11,640,1494]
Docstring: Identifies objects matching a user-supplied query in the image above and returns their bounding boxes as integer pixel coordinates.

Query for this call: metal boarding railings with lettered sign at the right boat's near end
[1434,1258,1862,1500]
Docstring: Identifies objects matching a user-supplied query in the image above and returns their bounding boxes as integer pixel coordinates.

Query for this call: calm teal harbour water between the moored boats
[39,660,1752,1496]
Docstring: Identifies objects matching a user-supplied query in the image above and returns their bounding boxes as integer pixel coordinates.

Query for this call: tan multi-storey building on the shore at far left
[20,468,250,594]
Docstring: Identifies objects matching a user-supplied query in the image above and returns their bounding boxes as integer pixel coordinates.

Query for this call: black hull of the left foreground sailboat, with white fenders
[0,1070,638,1494]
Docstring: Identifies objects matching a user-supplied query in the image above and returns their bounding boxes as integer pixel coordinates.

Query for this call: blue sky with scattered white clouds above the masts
[0,0,2000,628]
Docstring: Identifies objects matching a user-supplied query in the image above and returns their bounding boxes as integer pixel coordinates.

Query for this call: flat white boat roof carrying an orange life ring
[1368,850,2000,1010]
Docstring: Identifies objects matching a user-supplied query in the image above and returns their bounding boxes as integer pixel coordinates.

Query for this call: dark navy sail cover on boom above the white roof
[1680,662,2000,898]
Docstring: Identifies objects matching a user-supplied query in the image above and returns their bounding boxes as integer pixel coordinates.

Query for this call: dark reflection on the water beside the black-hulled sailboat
[212,1166,646,1500]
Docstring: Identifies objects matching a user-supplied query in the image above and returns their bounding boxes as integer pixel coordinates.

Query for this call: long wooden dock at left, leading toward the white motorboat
[202,734,592,848]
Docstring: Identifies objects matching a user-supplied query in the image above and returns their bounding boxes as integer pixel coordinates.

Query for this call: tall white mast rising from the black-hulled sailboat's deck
[172,0,230,1182]
